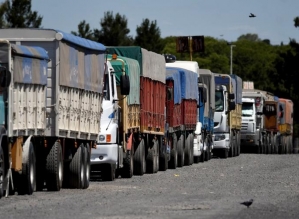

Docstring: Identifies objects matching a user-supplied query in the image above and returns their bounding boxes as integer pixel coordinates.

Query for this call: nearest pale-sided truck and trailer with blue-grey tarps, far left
[0,28,126,198]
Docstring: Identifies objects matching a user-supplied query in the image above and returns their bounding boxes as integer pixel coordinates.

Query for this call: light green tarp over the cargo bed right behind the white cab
[107,55,140,105]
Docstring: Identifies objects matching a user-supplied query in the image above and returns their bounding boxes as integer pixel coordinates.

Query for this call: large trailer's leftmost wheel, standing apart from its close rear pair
[46,142,63,191]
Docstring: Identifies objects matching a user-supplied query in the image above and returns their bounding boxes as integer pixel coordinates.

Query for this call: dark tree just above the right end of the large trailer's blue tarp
[94,11,133,46]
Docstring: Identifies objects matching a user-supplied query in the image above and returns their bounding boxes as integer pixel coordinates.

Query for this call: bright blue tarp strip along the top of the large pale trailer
[55,30,106,52]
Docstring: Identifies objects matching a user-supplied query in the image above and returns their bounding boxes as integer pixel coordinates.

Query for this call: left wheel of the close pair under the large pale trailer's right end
[68,145,85,189]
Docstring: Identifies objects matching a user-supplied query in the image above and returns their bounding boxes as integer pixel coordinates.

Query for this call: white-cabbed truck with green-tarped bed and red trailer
[91,46,169,180]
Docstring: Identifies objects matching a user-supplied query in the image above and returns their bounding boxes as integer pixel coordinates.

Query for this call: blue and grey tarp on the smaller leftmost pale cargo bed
[11,44,49,85]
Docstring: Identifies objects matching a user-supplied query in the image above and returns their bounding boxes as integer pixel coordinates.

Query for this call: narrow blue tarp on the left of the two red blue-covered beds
[166,67,182,104]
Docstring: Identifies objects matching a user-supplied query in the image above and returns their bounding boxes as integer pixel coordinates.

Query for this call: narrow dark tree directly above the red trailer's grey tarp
[135,19,165,53]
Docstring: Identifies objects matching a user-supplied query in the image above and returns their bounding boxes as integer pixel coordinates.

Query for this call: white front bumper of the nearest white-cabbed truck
[90,144,118,165]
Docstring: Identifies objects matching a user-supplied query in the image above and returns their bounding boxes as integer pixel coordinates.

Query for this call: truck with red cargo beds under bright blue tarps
[166,67,199,169]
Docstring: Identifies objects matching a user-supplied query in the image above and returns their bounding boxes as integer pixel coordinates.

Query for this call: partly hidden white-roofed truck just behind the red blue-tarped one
[165,57,215,163]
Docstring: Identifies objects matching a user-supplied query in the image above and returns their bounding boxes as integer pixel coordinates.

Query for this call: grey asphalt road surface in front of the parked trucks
[0,154,299,219]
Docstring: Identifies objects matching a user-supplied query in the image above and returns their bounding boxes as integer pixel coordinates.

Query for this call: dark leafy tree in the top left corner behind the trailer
[0,0,43,28]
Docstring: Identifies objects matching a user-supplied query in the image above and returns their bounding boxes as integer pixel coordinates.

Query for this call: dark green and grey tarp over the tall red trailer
[107,46,166,84]
